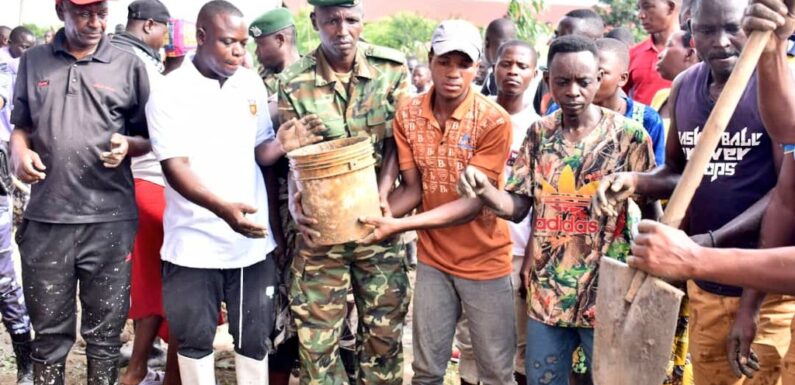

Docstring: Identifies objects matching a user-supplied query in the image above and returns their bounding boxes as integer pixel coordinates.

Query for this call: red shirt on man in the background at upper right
[624,37,671,105]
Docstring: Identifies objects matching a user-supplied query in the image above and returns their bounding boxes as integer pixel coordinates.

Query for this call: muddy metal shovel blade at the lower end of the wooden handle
[593,257,684,385]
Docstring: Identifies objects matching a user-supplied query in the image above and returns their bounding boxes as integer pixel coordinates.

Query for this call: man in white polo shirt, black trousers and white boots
[146,0,318,385]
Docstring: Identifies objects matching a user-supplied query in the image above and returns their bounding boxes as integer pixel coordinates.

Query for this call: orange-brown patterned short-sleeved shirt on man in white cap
[395,89,511,280]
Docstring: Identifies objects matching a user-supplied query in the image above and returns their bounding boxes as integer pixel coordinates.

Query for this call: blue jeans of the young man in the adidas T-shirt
[524,319,593,385]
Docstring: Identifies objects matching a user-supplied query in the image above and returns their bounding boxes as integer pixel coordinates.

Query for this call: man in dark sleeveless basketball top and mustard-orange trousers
[596,0,795,385]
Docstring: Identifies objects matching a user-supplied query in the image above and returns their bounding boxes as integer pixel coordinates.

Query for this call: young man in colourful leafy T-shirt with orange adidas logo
[458,35,654,385]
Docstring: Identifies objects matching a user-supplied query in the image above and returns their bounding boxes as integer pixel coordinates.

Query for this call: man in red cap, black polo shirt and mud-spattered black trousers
[11,0,149,385]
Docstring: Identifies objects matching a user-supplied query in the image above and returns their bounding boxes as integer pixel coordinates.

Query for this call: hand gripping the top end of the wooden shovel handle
[743,0,795,52]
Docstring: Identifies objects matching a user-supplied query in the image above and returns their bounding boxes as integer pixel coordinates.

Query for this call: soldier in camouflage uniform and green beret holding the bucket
[279,0,410,385]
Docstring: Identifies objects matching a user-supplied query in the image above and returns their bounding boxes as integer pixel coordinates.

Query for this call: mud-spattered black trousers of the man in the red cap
[17,220,138,365]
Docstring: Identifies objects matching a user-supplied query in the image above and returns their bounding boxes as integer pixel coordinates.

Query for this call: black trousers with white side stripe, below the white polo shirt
[162,256,276,360]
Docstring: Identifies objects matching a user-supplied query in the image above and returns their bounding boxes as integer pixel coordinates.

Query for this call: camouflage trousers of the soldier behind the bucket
[290,236,411,385]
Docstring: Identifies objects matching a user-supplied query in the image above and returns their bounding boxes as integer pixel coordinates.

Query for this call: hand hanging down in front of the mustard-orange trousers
[726,308,759,378]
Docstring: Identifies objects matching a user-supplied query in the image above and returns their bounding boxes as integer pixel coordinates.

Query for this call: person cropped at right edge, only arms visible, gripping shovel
[630,0,795,384]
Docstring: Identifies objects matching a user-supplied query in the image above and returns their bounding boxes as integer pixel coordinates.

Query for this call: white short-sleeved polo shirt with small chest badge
[146,60,276,269]
